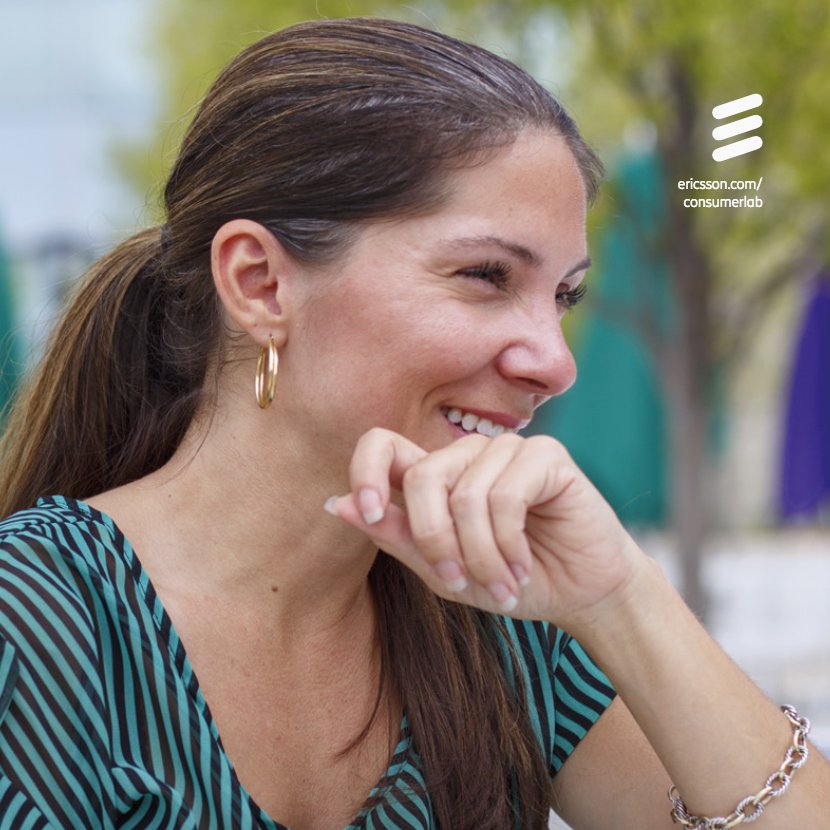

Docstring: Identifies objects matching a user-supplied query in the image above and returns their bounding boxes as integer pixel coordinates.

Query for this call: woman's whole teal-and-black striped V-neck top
[0,497,614,830]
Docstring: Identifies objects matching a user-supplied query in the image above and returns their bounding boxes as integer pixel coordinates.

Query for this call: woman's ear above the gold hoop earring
[210,219,298,347]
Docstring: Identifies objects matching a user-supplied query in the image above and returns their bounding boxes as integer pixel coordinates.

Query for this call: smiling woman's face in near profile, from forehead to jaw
[278,131,588,462]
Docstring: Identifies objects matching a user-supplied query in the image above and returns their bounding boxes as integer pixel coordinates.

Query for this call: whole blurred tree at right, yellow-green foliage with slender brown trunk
[540,0,830,615]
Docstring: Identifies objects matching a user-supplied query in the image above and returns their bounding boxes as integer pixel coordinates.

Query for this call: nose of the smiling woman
[499,310,576,397]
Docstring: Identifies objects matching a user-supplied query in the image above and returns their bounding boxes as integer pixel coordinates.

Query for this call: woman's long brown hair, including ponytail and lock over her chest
[0,19,601,830]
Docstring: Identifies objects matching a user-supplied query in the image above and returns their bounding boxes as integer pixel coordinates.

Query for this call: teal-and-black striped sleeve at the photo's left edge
[0,534,111,830]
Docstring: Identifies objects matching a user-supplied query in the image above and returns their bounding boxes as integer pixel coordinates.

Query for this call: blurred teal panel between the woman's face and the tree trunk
[533,156,674,525]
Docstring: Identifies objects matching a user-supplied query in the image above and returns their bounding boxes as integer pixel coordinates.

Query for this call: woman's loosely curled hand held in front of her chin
[326,428,643,627]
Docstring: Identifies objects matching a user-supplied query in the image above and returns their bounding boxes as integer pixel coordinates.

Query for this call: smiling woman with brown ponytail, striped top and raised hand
[0,14,830,830]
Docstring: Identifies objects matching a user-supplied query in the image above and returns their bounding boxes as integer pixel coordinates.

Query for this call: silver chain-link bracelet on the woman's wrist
[669,706,810,830]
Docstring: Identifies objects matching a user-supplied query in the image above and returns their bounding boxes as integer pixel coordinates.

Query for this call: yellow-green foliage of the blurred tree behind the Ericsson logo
[559,0,830,368]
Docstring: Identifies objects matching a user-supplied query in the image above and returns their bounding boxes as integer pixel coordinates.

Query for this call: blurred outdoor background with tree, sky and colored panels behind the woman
[0,0,830,820]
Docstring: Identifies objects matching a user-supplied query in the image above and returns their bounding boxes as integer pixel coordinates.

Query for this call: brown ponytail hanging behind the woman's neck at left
[0,227,218,516]
